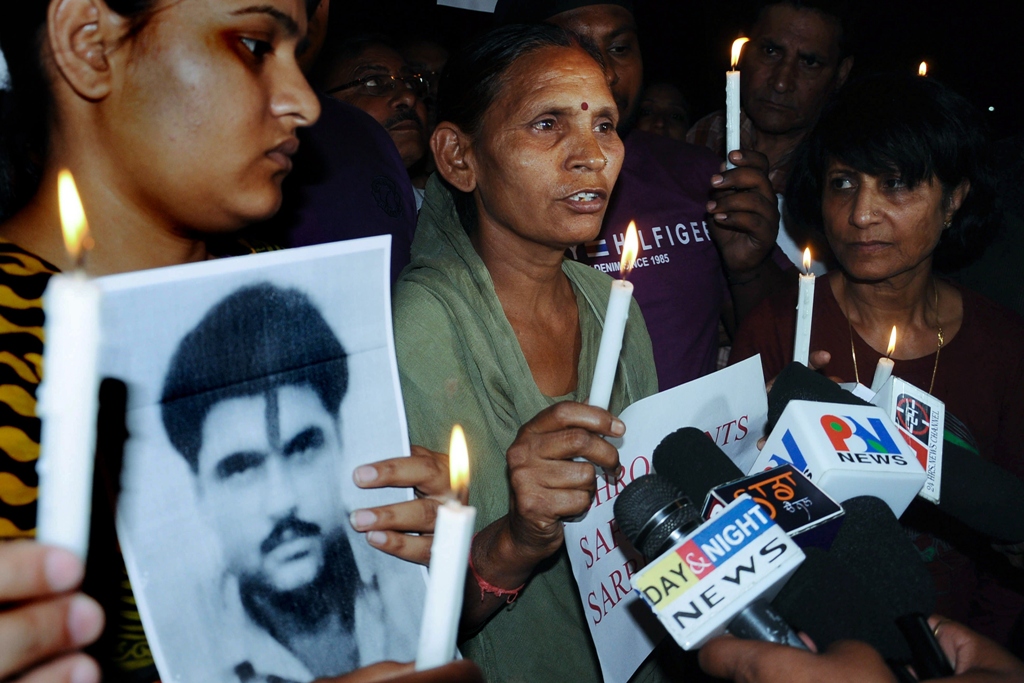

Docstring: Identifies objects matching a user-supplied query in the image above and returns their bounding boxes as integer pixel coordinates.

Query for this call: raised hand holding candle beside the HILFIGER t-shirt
[707,150,778,280]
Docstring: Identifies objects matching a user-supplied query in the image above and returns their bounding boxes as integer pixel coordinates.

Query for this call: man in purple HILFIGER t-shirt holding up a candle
[495,0,785,390]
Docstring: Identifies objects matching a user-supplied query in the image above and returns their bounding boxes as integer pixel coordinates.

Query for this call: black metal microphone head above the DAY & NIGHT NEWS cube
[614,474,702,560]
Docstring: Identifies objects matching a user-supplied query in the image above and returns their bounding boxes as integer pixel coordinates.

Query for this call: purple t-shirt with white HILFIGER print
[570,130,727,391]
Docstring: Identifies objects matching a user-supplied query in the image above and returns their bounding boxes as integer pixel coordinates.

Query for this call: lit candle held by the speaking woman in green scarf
[588,220,640,410]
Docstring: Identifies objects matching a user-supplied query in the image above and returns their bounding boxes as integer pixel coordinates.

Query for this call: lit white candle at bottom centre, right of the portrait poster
[416,425,476,671]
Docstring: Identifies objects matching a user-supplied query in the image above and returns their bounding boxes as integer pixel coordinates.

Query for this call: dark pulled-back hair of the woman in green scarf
[437,24,604,232]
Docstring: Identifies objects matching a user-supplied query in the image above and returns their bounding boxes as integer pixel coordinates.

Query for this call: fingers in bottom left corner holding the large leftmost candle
[0,541,103,683]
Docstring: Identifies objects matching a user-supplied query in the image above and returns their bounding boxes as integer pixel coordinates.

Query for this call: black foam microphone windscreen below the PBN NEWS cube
[828,496,935,621]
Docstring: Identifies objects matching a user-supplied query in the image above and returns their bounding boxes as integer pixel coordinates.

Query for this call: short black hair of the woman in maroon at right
[785,74,995,265]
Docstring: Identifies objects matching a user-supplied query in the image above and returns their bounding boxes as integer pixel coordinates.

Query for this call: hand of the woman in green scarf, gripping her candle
[506,401,626,561]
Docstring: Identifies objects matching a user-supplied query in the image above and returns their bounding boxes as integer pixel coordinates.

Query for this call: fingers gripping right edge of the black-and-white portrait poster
[349,445,450,564]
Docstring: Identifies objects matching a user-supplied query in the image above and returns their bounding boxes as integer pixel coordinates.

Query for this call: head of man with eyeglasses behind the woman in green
[314,36,428,209]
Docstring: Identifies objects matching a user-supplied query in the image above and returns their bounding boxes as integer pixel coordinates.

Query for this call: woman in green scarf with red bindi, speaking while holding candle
[356,26,657,681]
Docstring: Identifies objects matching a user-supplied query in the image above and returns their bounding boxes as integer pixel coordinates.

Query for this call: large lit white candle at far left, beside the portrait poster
[36,171,100,560]
